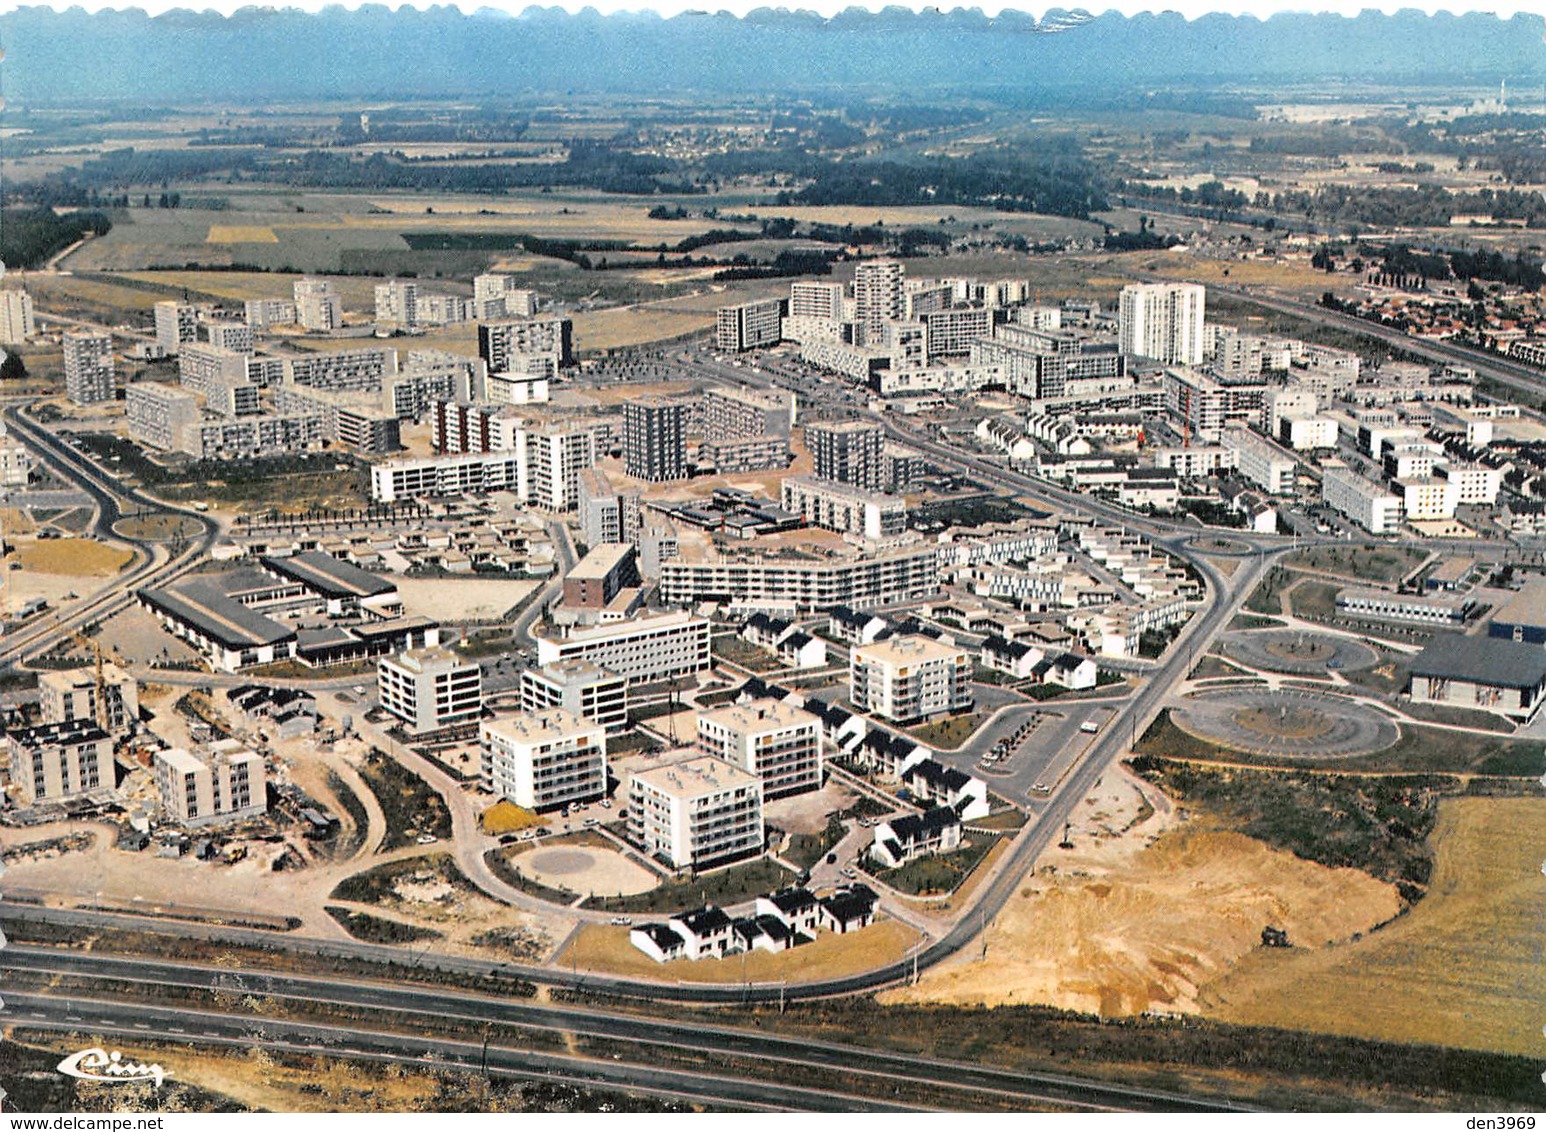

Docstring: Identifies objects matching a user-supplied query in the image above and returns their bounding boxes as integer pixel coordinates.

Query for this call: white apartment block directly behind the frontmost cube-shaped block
[697,699,821,800]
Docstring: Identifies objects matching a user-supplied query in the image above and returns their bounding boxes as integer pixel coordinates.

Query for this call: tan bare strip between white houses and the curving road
[553,920,921,982]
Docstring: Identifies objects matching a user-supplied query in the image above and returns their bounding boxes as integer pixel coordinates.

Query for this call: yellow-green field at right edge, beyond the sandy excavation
[1204,798,1546,1056]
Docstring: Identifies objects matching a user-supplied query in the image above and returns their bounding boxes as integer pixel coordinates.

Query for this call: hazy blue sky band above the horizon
[0,5,1546,105]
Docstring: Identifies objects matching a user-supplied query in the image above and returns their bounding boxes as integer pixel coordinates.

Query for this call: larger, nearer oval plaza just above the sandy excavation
[1170,688,1401,759]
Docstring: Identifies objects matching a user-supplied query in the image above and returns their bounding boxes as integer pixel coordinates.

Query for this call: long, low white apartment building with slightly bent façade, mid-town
[659,546,940,612]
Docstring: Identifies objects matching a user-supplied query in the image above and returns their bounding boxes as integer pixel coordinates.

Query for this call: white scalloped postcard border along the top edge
[0,0,1541,19]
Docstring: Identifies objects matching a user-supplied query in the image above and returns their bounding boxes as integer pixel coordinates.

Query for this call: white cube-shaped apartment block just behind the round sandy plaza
[479,708,606,813]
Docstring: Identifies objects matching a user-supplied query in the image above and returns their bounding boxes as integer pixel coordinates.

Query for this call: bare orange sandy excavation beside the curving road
[883,770,1401,1018]
